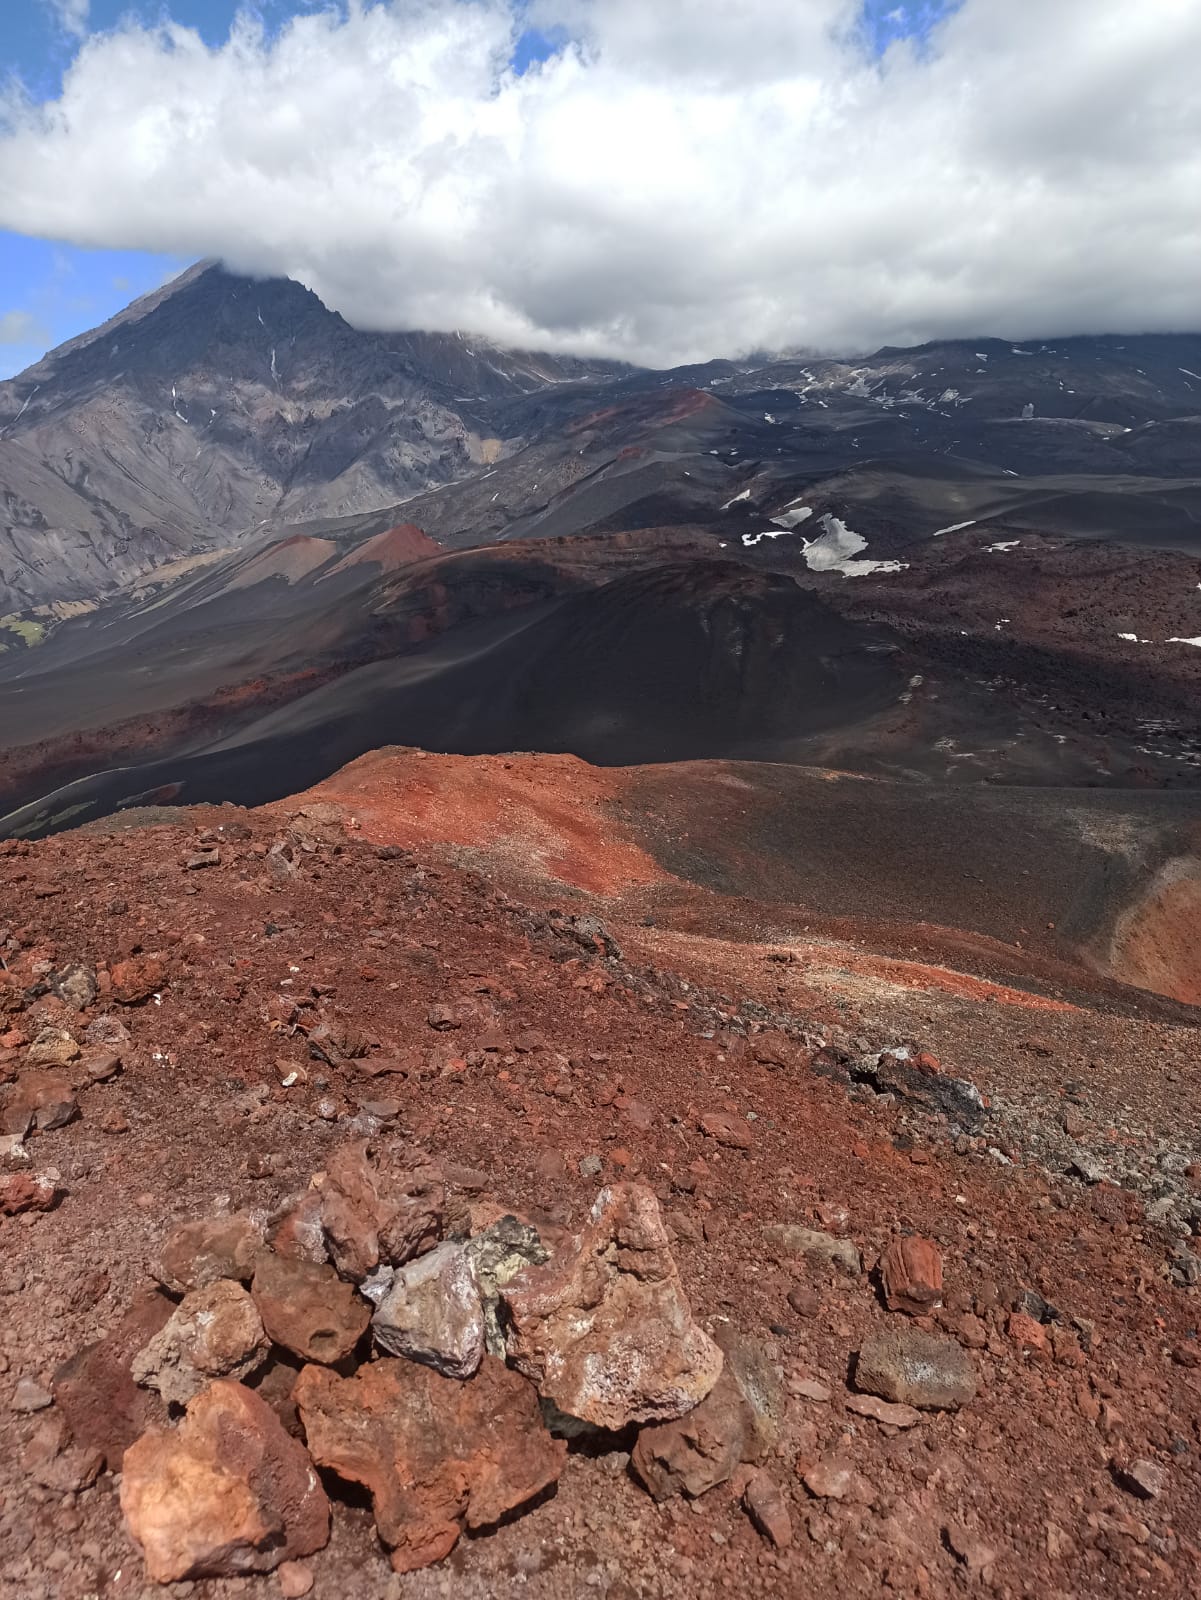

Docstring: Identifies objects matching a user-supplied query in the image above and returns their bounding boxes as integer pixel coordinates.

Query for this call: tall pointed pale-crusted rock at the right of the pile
[502,1184,723,1429]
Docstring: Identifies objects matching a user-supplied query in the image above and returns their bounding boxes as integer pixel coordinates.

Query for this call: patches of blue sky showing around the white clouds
[0,0,956,379]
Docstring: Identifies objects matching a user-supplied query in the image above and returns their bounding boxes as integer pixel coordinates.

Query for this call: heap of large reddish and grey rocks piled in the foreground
[101,1139,742,1582]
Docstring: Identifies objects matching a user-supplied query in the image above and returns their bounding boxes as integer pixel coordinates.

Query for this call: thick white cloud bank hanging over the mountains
[0,0,1201,363]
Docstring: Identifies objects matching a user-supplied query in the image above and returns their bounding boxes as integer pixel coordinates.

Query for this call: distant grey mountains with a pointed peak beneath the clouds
[0,264,1201,614]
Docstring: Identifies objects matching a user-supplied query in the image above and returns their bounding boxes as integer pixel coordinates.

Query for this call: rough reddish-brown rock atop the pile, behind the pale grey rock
[320,1139,446,1282]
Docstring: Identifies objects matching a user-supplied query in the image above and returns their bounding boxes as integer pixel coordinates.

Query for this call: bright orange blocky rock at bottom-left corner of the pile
[122,1379,329,1584]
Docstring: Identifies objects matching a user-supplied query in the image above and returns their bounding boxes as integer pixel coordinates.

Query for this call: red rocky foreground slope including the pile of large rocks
[0,790,1201,1600]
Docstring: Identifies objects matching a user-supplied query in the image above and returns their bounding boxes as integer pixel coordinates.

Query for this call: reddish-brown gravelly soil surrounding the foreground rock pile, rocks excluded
[0,790,1201,1600]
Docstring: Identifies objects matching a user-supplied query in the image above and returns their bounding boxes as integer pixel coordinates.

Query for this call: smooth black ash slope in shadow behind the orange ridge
[3,562,904,835]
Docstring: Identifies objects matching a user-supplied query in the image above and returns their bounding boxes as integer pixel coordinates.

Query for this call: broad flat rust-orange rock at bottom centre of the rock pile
[294,1355,566,1573]
